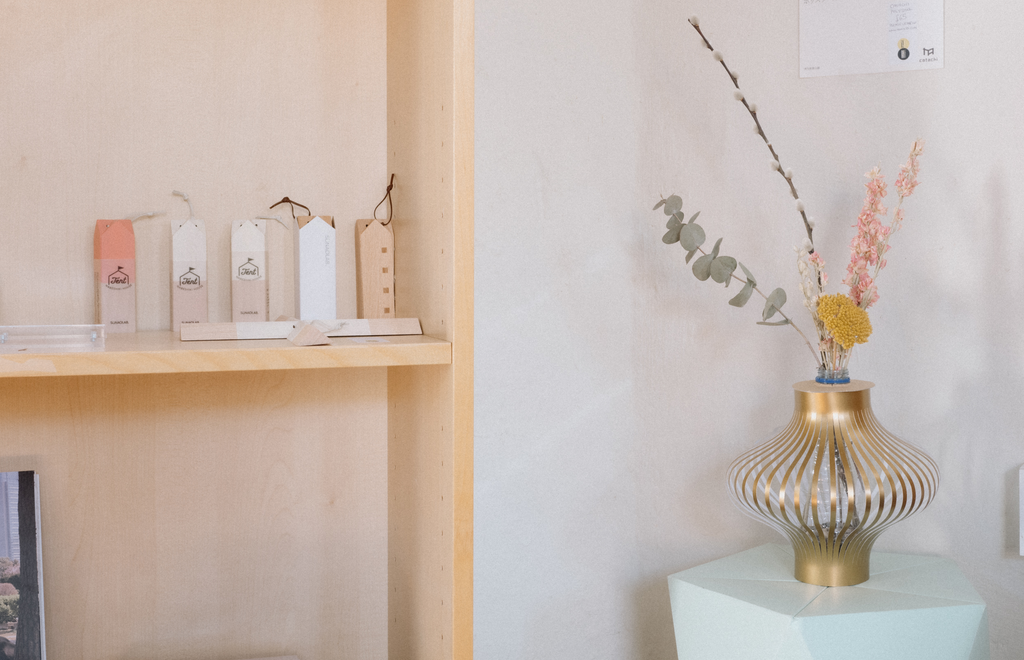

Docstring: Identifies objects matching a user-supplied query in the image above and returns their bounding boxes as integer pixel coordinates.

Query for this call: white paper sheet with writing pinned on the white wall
[799,0,943,78]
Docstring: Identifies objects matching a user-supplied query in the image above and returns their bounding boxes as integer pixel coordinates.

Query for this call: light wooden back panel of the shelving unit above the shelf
[0,0,387,331]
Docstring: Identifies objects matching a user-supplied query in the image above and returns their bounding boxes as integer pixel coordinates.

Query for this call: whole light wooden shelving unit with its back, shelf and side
[0,0,473,660]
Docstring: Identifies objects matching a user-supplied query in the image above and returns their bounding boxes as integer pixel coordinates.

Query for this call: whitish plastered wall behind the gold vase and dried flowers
[475,0,1024,660]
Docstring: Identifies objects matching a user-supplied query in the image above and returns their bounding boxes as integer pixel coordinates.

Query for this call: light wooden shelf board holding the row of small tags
[0,332,452,378]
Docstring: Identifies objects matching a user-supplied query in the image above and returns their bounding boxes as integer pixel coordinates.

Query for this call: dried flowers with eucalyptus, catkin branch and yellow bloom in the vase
[654,16,924,384]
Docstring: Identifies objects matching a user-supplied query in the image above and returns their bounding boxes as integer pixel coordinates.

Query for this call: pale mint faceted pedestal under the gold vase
[669,544,988,660]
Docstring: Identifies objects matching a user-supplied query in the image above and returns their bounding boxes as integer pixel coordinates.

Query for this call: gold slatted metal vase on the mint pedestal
[729,381,939,586]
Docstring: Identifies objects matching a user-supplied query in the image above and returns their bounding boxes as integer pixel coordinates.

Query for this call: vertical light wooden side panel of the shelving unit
[388,0,473,659]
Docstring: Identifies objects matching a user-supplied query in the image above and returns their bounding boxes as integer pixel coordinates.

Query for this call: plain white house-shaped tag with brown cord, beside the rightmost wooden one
[293,216,338,321]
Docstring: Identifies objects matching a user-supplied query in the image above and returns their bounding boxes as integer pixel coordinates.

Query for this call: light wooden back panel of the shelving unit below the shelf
[0,368,387,660]
